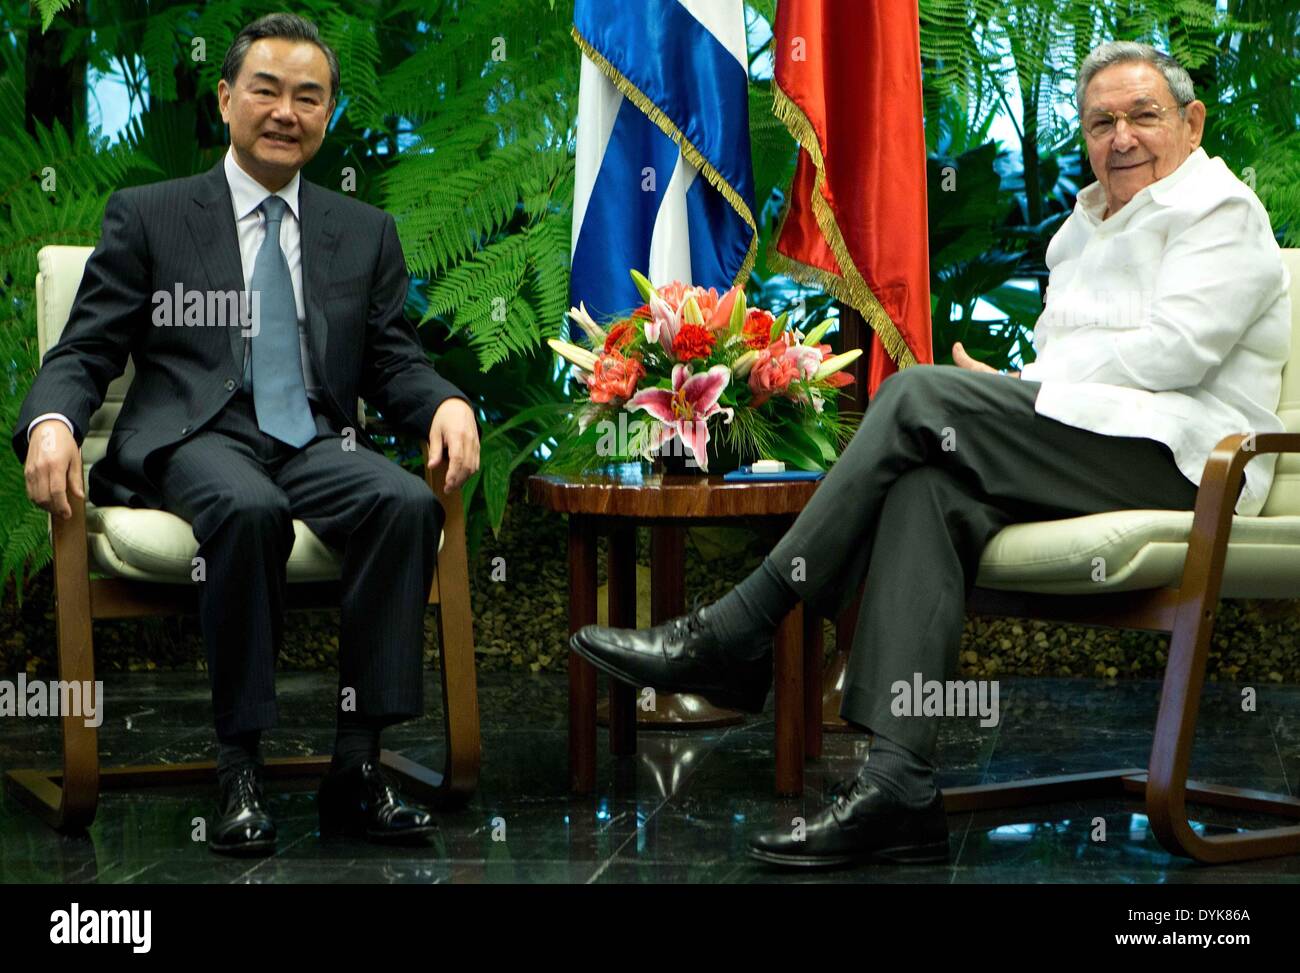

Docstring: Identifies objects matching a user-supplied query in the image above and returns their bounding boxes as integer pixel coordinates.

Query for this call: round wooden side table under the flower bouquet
[528,464,822,795]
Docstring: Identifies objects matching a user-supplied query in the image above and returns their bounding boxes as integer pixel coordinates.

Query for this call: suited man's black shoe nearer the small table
[316,760,438,843]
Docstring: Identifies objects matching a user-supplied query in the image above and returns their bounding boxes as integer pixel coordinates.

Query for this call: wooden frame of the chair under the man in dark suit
[5,424,480,833]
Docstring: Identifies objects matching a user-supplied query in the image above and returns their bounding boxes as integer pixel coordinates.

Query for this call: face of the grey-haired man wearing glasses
[1082,61,1205,217]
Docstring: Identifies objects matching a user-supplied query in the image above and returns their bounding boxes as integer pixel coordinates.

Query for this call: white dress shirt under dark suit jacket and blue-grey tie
[27,148,320,441]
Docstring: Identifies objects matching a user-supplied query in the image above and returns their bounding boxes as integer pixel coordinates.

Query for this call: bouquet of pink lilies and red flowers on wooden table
[546,271,862,472]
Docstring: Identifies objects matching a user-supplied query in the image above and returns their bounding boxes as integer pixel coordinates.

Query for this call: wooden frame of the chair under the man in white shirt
[805,433,1300,864]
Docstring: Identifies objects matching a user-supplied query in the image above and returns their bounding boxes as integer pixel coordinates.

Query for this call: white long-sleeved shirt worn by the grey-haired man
[1021,148,1291,515]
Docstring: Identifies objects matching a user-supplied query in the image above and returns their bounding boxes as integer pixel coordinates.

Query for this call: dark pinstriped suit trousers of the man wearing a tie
[150,392,445,736]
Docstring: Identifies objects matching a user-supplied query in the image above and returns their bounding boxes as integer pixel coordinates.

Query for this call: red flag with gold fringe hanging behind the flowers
[770,0,935,395]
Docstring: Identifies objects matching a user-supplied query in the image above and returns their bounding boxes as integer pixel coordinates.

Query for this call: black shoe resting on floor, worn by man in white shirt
[749,774,948,868]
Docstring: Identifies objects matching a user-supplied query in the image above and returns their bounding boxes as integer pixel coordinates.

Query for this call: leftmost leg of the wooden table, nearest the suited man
[568,514,595,793]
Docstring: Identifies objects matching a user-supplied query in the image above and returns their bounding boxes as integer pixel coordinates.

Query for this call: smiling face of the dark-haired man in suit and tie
[217,38,334,193]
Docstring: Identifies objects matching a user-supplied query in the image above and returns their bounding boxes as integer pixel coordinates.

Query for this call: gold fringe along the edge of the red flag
[767,81,917,368]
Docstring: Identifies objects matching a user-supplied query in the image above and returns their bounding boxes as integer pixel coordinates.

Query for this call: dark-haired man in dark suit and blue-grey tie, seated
[13,14,478,853]
